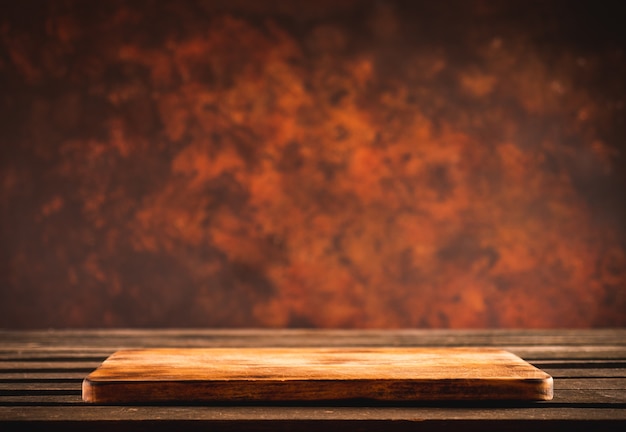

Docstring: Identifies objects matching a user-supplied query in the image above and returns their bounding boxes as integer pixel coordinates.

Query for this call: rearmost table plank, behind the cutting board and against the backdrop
[0,329,626,348]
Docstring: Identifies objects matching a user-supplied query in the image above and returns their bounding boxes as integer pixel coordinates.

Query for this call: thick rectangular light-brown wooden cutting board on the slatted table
[83,348,553,404]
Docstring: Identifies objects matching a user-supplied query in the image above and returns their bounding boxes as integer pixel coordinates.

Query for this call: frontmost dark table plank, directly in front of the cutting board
[0,403,626,422]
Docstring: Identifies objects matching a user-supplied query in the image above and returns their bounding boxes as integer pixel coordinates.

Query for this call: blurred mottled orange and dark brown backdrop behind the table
[0,0,626,328]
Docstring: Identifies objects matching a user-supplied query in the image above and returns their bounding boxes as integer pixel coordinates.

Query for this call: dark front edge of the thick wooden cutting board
[82,374,554,404]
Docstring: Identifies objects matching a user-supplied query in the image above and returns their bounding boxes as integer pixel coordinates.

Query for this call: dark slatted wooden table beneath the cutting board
[0,329,626,432]
